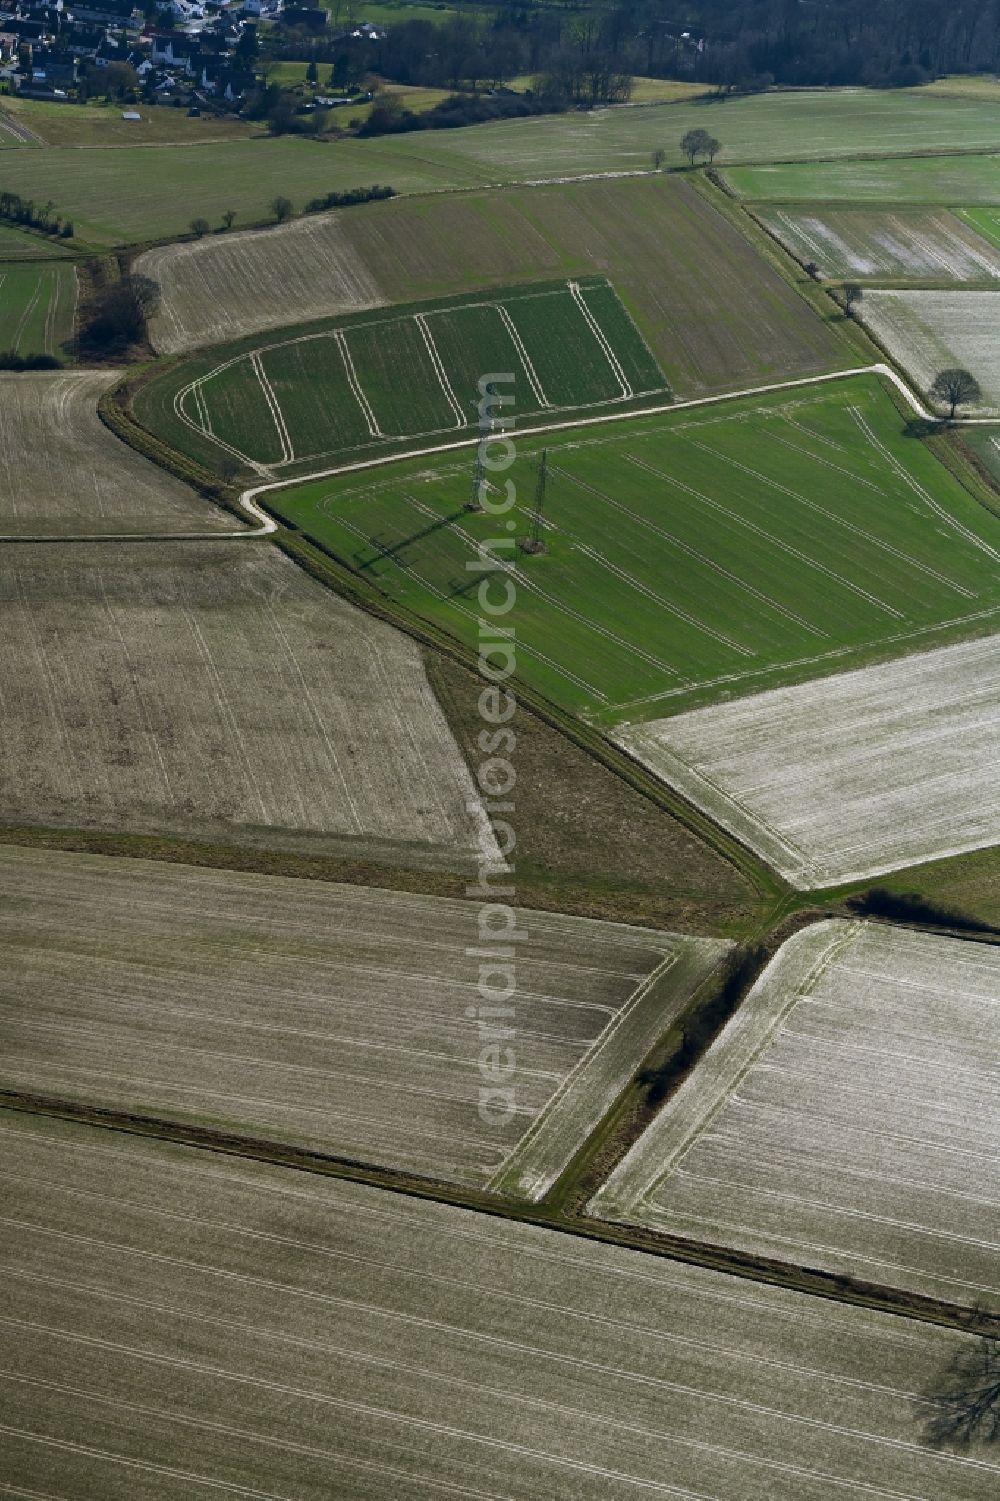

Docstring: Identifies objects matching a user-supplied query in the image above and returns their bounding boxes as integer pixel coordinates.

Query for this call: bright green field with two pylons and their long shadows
[270,377,1000,725]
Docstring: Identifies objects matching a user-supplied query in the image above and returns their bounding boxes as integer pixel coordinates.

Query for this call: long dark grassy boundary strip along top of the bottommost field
[0,1090,1000,1334]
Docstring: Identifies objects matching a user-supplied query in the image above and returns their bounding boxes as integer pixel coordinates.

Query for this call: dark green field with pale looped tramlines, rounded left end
[138,278,660,474]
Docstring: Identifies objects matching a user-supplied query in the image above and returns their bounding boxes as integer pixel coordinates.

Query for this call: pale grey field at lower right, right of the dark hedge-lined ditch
[592,922,1000,1307]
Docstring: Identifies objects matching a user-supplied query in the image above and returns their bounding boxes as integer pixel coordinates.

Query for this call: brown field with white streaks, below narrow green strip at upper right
[758,207,1000,282]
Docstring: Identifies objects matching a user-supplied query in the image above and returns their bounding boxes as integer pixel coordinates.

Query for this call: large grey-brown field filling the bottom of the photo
[0,1114,1000,1501]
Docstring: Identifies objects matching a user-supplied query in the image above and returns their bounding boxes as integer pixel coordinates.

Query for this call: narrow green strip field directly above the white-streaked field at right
[724,153,1000,206]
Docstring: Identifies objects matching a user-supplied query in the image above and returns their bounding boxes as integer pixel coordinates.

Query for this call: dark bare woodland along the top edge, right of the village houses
[278,0,1000,108]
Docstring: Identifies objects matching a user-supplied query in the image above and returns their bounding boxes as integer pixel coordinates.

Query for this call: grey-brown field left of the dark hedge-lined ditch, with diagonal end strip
[0,847,728,1198]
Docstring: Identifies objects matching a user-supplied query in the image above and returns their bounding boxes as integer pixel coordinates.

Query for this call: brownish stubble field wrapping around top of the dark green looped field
[140,176,850,395]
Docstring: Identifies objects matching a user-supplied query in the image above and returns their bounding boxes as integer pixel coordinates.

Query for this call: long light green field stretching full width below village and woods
[3,89,1000,243]
